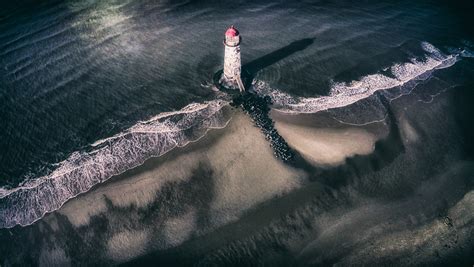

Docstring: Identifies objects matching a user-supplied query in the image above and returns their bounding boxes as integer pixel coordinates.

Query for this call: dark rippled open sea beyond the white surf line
[0,1,470,186]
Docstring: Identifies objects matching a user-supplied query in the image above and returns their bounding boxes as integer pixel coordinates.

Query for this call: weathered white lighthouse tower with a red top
[220,25,245,92]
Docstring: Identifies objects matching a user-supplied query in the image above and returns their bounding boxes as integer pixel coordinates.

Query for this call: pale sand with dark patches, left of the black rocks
[36,108,307,263]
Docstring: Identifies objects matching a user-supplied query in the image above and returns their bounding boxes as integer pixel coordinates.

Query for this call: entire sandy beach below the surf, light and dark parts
[0,85,474,266]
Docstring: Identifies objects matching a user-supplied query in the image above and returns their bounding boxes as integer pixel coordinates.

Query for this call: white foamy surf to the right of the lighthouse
[253,42,466,113]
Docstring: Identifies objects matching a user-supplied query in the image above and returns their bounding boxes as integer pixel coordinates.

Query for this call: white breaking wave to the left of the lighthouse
[0,100,228,228]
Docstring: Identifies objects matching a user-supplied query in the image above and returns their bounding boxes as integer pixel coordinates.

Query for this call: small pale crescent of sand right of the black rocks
[272,110,388,167]
